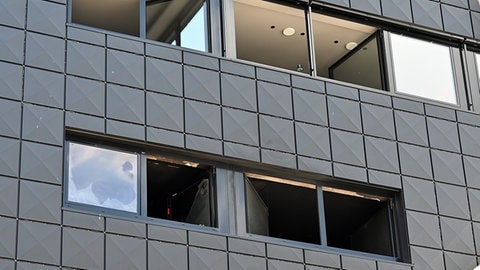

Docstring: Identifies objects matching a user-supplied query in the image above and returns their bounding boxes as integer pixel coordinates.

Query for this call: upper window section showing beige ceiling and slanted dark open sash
[312,12,382,89]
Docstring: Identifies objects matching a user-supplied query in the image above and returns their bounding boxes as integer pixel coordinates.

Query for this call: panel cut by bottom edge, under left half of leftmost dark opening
[148,241,188,270]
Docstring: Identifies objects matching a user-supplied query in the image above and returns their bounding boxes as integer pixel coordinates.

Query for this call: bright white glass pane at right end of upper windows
[390,34,457,104]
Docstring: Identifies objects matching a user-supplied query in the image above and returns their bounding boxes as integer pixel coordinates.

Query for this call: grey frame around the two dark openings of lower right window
[239,171,410,262]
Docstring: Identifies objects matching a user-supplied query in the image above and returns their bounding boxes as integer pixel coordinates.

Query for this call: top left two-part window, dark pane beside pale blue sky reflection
[71,0,209,51]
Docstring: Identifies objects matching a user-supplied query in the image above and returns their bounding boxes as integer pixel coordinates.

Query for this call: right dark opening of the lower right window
[323,191,393,256]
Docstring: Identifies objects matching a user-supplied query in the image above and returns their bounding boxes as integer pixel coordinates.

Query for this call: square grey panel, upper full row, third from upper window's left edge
[145,57,183,96]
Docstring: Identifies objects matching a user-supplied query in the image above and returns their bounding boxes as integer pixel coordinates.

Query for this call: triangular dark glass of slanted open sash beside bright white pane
[330,36,383,89]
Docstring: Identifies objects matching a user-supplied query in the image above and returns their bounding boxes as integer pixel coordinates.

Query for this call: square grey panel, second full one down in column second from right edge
[432,150,465,186]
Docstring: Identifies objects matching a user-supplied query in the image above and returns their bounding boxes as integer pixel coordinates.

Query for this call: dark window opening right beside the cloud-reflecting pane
[147,159,216,226]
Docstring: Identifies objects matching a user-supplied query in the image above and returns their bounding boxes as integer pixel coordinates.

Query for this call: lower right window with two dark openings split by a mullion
[245,173,402,258]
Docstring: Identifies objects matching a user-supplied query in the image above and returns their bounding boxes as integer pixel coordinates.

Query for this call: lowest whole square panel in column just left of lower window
[17,220,61,265]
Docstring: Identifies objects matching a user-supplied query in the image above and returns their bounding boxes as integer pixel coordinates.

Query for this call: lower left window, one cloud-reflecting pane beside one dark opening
[66,142,217,227]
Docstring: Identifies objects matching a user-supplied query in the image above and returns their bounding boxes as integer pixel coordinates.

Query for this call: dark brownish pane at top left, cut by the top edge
[72,0,140,36]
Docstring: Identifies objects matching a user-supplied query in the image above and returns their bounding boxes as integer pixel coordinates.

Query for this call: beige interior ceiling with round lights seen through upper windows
[235,0,376,77]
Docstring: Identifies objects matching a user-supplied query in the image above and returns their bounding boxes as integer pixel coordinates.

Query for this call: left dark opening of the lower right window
[246,178,320,244]
